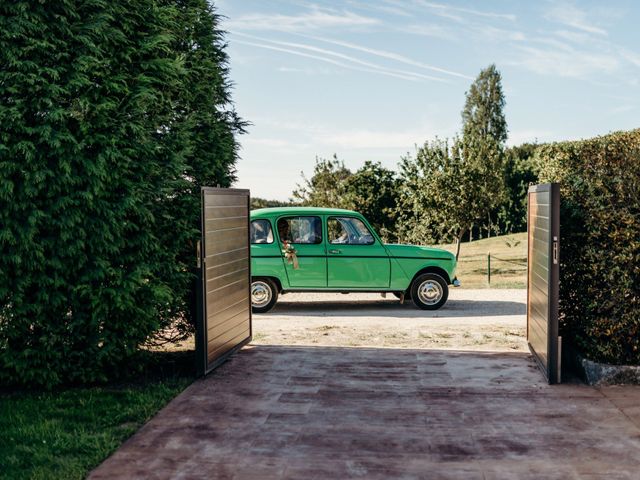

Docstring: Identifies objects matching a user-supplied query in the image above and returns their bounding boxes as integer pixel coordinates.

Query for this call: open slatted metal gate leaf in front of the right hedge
[527,183,562,384]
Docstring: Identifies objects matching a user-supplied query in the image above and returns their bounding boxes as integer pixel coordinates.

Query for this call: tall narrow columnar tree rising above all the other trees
[462,65,507,240]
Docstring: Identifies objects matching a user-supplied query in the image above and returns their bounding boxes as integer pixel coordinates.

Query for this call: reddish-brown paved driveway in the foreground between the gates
[91,346,640,480]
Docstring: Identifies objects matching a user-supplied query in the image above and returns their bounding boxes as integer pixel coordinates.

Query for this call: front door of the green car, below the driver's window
[326,216,391,289]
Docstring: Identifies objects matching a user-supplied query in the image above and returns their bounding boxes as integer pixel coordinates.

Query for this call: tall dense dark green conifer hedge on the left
[0,0,243,386]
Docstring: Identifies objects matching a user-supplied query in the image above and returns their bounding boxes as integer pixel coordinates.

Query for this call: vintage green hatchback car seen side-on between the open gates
[250,207,460,313]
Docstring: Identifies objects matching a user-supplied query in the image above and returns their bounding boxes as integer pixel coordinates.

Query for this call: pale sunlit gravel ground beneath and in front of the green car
[252,289,528,352]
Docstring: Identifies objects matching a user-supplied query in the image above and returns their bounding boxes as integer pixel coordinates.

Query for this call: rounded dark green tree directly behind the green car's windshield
[346,161,397,241]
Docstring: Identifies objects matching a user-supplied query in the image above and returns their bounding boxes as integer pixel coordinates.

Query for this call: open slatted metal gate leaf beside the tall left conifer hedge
[196,187,252,375]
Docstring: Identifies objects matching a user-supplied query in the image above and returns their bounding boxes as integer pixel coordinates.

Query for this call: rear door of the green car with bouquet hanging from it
[277,215,327,288]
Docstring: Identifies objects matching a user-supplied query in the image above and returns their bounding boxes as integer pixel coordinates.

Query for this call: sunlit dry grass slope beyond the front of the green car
[440,233,527,288]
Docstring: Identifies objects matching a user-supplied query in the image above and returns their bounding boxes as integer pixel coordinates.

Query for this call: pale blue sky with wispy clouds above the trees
[215,0,640,200]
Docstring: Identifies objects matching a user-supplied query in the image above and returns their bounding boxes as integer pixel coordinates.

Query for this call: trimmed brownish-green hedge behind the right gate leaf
[538,129,640,365]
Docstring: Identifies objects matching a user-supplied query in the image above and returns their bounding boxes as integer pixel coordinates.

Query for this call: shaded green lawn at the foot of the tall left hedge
[0,352,194,479]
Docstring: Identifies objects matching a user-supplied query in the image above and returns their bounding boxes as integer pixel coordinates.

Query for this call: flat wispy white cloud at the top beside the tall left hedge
[225,7,380,32]
